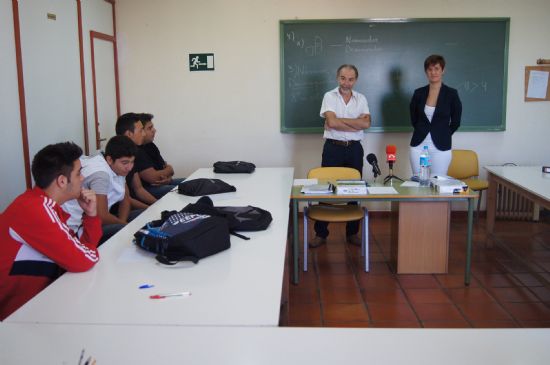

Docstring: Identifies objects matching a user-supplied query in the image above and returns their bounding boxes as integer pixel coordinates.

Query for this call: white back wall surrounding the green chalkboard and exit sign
[122,0,550,208]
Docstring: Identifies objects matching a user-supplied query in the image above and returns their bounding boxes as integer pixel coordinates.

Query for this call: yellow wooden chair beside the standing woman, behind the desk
[447,150,489,220]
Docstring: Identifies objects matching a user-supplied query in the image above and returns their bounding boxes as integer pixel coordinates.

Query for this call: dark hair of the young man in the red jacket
[31,142,82,189]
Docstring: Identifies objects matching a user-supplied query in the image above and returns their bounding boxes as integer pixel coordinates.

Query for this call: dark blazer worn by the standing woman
[410,84,462,151]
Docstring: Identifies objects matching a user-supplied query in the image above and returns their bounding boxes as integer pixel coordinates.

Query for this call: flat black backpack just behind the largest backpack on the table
[181,196,273,240]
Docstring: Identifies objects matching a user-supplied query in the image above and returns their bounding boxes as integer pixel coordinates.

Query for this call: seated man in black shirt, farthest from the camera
[136,113,185,199]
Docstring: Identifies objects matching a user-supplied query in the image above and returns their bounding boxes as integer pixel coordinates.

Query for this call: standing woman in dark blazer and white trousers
[409,55,462,176]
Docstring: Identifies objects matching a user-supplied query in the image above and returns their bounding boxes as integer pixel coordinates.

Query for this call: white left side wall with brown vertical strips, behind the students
[0,0,113,211]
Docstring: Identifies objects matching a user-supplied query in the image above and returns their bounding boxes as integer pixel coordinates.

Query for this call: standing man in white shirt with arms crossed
[309,65,370,248]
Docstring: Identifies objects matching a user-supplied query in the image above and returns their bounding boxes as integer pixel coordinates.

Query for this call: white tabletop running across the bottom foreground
[0,323,550,365]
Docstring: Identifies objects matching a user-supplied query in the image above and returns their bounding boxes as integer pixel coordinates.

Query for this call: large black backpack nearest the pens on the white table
[134,211,231,265]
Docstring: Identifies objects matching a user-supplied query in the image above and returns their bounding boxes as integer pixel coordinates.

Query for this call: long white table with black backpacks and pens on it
[6,168,293,326]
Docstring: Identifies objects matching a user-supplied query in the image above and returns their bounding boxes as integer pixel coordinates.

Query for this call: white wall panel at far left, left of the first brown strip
[0,0,26,212]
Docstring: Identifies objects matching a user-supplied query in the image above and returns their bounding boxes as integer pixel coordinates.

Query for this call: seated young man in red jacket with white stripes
[0,142,101,321]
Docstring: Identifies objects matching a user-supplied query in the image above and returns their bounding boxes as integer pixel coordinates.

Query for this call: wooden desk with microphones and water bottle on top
[291,183,477,285]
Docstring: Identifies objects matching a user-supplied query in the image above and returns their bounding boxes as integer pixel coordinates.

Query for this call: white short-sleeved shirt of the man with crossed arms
[320,88,370,141]
